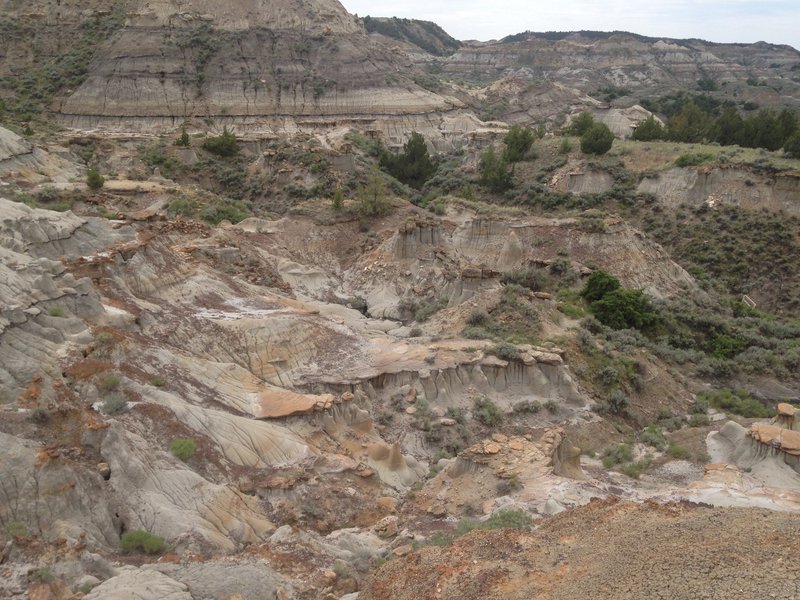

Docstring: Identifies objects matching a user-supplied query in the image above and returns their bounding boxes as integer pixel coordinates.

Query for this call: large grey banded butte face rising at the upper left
[47,1,457,129]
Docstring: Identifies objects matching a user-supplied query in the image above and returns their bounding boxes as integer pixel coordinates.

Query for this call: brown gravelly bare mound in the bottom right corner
[359,500,800,600]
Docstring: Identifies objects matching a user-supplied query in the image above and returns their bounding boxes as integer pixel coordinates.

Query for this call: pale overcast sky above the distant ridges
[340,0,800,48]
